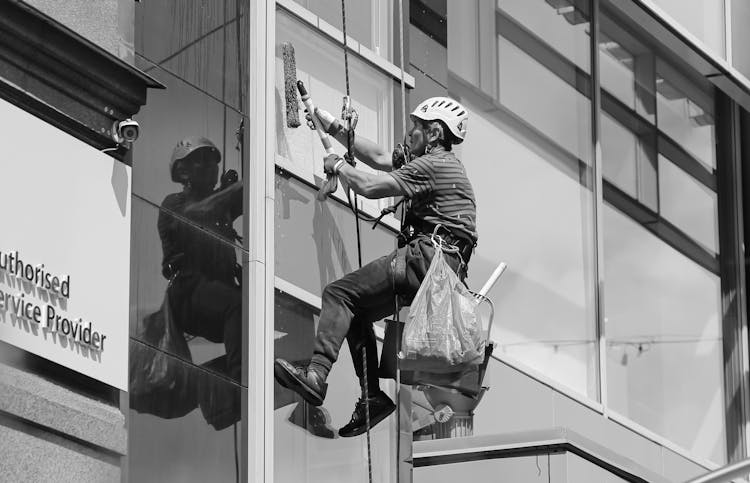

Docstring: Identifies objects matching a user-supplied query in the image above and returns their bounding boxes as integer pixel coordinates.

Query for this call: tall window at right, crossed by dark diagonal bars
[600,2,726,463]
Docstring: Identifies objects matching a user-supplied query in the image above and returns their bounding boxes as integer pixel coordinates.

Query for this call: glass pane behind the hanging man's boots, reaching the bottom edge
[274,290,397,483]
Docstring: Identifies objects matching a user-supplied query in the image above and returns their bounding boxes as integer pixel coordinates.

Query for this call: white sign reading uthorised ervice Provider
[0,100,131,390]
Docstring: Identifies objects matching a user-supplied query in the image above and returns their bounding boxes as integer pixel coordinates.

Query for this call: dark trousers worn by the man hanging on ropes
[314,236,461,390]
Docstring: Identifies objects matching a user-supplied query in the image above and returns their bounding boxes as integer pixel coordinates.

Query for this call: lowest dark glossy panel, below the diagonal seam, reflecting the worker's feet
[128,339,247,483]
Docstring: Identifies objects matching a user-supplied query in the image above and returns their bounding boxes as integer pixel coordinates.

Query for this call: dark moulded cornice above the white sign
[0,0,164,163]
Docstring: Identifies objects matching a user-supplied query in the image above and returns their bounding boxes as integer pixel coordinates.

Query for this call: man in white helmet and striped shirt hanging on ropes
[274,97,477,437]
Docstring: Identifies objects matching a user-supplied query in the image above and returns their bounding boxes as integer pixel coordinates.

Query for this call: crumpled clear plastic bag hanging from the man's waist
[399,240,485,373]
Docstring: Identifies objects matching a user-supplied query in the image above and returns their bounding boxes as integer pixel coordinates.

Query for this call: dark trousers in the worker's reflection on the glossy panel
[169,274,242,381]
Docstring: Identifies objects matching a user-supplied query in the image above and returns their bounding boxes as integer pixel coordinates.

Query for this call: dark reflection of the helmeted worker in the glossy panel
[158,137,242,380]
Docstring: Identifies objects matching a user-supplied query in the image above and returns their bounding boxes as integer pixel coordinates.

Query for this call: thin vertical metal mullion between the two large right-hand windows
[589,0,607,414]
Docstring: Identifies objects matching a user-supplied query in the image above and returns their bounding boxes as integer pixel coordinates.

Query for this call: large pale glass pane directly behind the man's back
[459,103,597,398]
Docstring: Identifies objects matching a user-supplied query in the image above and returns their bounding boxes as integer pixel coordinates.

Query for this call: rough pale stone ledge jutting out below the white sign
[0,364,127,455]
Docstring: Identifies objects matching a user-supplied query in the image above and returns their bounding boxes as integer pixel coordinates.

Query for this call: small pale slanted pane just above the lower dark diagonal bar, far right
[659,155,719,253]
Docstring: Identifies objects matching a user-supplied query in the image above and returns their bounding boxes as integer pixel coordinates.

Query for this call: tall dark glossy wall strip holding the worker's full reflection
[128,0,250,481]
